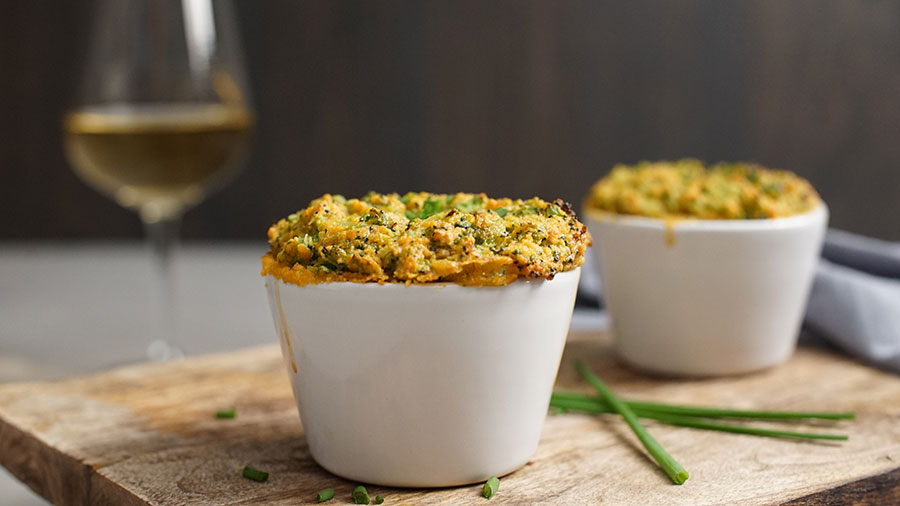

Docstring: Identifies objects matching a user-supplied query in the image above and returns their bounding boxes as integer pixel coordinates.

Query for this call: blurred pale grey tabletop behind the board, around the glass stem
[0,242,275,506]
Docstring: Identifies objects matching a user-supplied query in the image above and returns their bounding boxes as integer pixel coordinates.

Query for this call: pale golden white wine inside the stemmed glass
[64,104,252,221]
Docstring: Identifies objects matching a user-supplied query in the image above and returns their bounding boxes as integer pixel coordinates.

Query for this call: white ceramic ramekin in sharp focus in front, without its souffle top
[266,269,580,487]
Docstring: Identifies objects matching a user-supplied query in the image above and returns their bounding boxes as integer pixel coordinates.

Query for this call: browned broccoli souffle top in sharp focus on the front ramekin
[263,192,591,286]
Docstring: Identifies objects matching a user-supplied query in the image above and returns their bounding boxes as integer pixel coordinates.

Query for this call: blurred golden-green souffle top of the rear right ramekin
[585,159,819,220]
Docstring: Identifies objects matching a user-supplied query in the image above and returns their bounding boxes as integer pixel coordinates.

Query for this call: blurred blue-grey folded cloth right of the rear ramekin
[804,229,900,374]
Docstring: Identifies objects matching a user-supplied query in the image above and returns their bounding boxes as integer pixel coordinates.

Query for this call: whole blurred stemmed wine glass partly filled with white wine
[63,0,253,360]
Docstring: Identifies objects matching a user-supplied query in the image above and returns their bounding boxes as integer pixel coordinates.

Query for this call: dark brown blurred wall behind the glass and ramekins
[0,0,900,239]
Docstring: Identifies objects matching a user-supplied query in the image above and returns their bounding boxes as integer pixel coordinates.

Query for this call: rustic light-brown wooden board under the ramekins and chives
[0,334,900,506]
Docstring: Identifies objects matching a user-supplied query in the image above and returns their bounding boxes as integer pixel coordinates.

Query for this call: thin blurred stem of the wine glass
[142,215,184,361]
